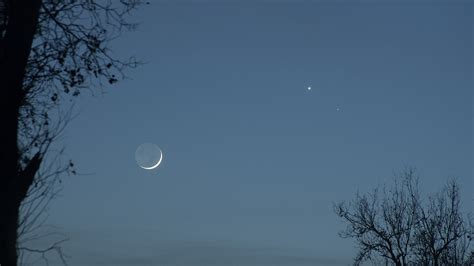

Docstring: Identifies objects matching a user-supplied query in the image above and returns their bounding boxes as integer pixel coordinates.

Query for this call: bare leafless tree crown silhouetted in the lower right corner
[335,169,474,266]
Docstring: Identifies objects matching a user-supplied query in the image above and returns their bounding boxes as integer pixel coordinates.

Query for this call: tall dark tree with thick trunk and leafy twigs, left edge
[0,0,141,266]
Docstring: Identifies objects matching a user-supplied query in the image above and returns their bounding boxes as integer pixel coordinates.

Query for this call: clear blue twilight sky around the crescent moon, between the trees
[35,1,474,266]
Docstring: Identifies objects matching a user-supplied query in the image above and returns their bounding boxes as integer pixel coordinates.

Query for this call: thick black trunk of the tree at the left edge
[0,0,41,266]
